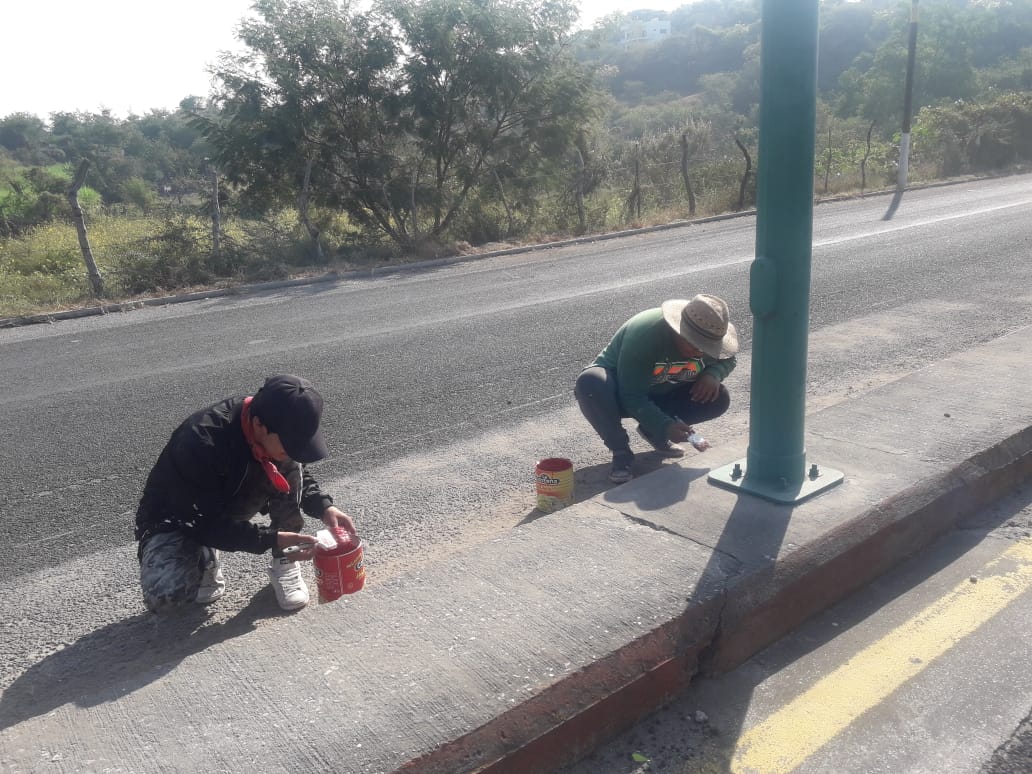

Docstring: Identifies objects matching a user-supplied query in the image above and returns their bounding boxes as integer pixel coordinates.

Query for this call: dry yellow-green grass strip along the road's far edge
[0,168,990,318]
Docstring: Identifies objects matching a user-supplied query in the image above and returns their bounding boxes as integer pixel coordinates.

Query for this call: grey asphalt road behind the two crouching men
[0,175,1032,598]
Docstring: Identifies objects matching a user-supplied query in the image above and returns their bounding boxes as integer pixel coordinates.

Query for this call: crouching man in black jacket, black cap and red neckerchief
[136,376,355,612]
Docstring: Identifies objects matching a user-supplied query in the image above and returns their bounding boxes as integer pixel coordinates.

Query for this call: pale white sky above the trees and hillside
[0,0,687,120]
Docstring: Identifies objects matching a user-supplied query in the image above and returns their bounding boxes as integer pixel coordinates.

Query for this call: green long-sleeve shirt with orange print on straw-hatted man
[591,307,737,438]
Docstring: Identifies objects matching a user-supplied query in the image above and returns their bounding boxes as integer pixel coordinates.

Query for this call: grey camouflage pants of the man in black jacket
[139,463,304,613]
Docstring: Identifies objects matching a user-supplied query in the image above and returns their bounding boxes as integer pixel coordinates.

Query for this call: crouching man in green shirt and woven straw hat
[574,294,738,483]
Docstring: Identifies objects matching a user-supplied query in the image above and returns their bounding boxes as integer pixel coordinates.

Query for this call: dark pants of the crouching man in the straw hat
[574,366,731,453]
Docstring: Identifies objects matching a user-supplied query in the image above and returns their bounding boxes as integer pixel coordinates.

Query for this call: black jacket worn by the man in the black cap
[135,397,333,553]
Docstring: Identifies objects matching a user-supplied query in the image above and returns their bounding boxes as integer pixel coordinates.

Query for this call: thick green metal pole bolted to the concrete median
[710,0,842,503]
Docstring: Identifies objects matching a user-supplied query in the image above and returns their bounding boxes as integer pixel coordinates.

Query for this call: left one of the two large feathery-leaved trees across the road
[194,0,398,255]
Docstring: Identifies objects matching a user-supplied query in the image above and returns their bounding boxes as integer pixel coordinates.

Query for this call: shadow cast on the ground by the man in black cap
[0,587,289,731]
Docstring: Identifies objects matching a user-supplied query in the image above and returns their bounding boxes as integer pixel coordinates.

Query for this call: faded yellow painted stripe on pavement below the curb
[731,540,1032,774]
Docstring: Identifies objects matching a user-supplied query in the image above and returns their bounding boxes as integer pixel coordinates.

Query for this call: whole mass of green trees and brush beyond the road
[0,0,1032,317]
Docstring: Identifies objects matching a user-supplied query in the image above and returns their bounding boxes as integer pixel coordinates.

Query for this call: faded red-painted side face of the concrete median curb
[398,426,1032,774]
